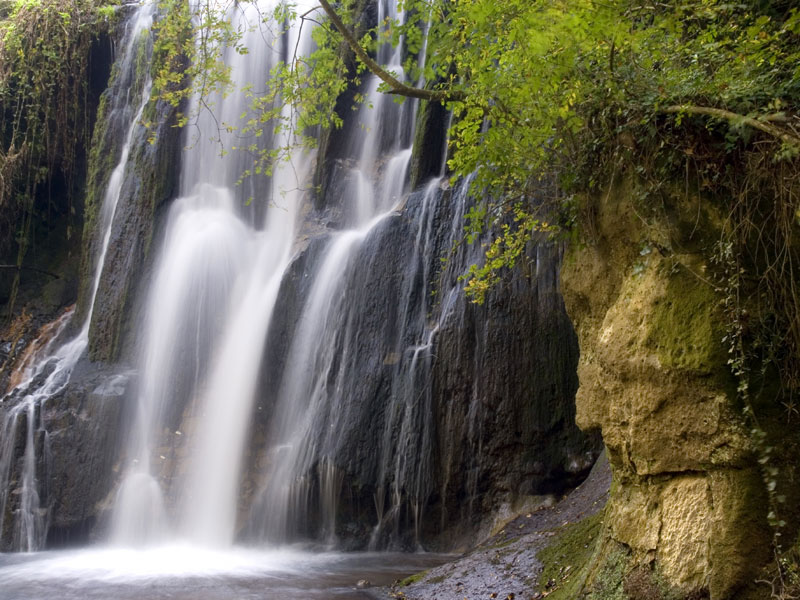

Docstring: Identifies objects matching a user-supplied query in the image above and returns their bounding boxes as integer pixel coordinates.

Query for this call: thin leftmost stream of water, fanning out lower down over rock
[0,3,155,551]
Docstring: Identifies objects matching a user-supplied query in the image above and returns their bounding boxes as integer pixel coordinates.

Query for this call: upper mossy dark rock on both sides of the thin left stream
[74,10,183,362]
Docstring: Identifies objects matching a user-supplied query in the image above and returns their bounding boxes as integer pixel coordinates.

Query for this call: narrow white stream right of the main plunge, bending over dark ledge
[251,0,428,545]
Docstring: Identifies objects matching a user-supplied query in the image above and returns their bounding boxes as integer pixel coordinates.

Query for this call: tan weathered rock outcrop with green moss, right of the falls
[562,186,770,599]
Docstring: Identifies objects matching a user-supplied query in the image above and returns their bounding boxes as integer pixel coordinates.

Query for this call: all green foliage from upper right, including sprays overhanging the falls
[123,0,800,406]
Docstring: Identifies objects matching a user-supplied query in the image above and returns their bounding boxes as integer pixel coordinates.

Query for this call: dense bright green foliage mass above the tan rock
[405,0,800,302]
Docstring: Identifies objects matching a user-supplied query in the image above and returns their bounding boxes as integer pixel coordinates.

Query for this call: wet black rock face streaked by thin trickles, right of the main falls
[249,177,600,548]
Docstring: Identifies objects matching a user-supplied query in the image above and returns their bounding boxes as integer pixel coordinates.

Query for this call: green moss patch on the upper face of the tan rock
[650,269,727,375]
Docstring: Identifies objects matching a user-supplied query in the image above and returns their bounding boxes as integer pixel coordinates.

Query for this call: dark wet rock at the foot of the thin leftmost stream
[0,361,132,550]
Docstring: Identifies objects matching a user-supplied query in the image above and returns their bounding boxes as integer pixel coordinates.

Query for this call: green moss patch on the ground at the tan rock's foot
[537,511,603,600]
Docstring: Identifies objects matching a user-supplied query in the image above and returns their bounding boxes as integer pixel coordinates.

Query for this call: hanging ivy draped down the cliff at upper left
[0,0,117,310]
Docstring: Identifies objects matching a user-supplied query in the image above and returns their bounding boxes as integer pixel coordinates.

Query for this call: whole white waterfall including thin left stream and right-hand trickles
[0,0,592,553]
